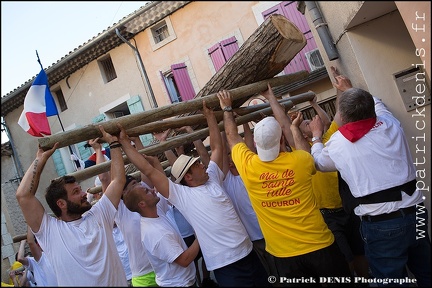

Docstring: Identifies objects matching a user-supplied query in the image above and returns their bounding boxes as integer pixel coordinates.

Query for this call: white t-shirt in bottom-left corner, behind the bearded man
[27,252,58,287]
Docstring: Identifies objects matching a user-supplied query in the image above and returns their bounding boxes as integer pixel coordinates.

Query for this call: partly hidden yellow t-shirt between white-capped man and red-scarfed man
[312,121,342,209]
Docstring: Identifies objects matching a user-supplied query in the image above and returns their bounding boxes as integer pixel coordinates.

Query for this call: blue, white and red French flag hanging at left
[18,69,58,137]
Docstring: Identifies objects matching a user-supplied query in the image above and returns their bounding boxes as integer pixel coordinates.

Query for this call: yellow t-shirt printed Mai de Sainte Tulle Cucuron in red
[231,143,334,257]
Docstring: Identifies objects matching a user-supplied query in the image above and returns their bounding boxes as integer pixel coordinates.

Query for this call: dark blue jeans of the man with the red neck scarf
[360,205,431,287]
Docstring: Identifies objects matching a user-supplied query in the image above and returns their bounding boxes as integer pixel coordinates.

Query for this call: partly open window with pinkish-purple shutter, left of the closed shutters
[160,63,196,103]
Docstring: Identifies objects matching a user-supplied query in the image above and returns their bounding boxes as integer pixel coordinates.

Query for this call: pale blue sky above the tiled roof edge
[1,1,148,143]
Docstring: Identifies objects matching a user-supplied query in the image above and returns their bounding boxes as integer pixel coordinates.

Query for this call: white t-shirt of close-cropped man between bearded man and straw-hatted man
[141,214,196,287]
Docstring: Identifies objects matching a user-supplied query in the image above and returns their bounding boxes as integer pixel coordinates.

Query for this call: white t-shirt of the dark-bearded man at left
[32,195,127,287]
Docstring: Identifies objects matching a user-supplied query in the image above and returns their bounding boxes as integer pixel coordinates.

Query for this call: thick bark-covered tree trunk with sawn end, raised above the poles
[196,14,306,107]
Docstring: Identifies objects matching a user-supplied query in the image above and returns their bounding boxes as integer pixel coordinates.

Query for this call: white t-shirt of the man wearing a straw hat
[168,161,252,271]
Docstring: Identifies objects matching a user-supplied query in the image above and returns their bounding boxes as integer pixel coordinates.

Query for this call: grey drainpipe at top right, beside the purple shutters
[305,1,339,61]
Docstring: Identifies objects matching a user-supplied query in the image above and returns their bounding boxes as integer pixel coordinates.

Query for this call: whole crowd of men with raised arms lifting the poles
[8,67,431,287]
